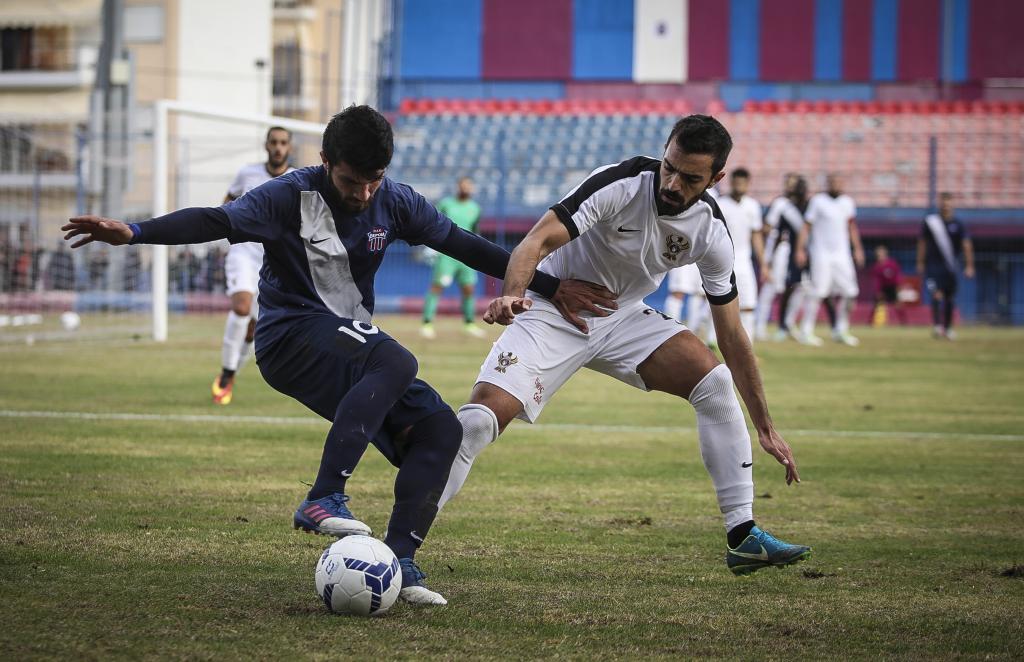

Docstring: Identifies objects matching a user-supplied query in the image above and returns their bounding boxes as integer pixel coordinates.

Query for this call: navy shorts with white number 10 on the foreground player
[256,314,452,466]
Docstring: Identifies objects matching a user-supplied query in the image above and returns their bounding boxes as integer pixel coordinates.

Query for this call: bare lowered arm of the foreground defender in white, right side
[711,298,800,485]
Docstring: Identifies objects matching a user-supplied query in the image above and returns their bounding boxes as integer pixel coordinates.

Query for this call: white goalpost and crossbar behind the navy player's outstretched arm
[152,99,325,342]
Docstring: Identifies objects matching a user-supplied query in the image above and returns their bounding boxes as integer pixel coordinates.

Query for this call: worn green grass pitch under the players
[0,317,1024,660]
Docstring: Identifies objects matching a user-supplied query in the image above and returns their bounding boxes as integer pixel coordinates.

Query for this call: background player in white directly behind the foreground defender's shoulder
[718,168,765,342]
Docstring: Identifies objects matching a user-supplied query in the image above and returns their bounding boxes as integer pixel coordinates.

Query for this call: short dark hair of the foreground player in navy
[323,106,394,175]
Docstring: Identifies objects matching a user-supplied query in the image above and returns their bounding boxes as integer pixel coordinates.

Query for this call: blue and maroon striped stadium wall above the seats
[383,0,1024,110]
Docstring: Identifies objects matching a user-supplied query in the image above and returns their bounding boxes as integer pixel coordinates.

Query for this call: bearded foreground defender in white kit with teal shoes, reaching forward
[440,115,810,574]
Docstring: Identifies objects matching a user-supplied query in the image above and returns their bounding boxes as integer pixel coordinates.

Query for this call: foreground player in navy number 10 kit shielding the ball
[63,106,613,605]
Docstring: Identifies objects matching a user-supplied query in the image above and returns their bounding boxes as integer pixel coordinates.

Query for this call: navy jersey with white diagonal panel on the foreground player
[222,166,453,341]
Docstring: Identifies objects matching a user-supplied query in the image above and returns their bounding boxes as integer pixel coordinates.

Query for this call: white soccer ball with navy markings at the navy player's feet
[316,536,401,616]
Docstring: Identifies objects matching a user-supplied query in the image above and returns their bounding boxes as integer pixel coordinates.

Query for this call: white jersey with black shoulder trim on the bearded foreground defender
[538,157,736,308]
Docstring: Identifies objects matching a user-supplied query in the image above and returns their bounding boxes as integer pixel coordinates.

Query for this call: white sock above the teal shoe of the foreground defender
[689,365,754,531]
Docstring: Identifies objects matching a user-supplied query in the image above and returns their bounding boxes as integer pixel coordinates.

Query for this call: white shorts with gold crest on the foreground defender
[476,299,687,423]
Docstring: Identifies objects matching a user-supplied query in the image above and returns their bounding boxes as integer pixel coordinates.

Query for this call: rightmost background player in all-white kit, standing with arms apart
[797,174,864,345]
